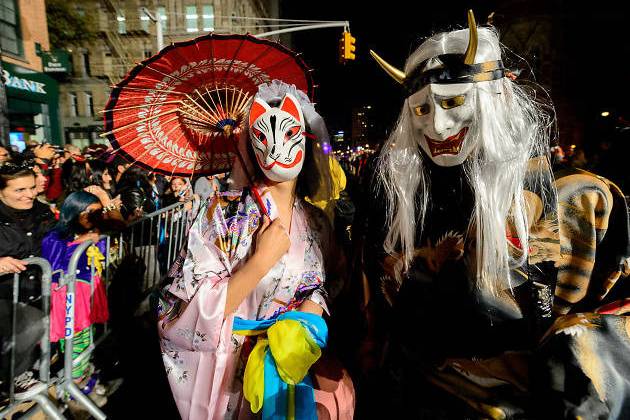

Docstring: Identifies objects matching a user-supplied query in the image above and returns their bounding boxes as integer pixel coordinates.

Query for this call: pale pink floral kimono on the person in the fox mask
[159,187,330,419]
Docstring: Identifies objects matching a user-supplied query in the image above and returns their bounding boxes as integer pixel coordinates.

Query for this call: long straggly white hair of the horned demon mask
[378,28,553,295]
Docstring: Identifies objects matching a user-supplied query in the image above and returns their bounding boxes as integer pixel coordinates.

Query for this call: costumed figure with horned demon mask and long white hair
[365,12,630,419]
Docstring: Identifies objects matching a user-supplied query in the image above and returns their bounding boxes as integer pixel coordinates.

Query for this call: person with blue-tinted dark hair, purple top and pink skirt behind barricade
[42,191,109,404]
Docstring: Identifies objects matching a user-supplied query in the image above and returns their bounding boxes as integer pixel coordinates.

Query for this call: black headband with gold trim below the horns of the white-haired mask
[404,54,506,95]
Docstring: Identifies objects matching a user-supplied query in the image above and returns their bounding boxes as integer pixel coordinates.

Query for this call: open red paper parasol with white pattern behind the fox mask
[103,34,313,176]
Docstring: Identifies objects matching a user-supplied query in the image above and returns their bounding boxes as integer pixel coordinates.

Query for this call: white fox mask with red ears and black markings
[249,93,306,182]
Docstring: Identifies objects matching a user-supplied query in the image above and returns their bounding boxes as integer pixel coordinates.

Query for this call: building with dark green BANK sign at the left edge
[0,0,61,149]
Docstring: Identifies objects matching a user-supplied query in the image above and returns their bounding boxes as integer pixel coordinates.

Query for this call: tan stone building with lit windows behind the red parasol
[60,0,278,147]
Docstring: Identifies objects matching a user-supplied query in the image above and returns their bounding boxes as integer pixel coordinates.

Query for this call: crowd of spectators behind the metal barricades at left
[0,142,230,405]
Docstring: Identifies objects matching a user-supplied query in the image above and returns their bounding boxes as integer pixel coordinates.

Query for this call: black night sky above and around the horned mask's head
[282,0,630,148]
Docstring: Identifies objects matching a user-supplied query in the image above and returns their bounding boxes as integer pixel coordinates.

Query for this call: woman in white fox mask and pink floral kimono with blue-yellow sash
[158,80,352,419]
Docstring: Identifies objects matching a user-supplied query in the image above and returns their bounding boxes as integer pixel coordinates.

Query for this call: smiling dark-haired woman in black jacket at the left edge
[0,162,54,397]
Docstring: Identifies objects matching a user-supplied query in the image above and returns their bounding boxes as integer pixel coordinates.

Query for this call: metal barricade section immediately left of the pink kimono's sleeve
[118,201,192,293]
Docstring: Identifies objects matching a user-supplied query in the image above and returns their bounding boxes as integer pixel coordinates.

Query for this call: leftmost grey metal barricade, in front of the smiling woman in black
[0,258,65,420]
